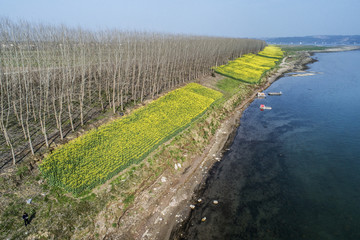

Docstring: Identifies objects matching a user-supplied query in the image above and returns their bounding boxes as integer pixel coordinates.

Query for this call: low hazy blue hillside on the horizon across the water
[263,35,360,45]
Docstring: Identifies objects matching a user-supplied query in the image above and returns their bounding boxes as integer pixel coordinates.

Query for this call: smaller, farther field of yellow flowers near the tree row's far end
[215,46,283,83]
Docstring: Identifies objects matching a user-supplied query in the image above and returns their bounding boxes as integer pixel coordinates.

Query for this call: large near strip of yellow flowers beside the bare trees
[40,83,222,194]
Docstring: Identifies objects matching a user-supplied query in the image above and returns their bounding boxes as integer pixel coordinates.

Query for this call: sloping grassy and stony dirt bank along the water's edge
[82,47,312,239]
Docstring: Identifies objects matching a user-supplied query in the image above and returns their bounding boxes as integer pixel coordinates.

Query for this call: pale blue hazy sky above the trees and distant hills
[0,0,360,38]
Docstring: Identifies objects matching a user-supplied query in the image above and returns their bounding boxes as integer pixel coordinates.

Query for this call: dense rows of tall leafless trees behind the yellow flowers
[0,19,265,167]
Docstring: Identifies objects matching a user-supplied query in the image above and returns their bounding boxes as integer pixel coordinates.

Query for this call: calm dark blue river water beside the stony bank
[183,51,360,240]
